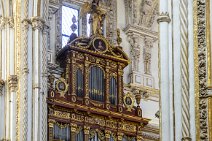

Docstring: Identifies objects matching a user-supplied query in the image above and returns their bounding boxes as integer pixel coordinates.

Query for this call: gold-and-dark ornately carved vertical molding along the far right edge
[194,0,209,141]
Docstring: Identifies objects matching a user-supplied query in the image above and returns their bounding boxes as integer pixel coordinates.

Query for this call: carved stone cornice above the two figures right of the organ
[123,24,158,40]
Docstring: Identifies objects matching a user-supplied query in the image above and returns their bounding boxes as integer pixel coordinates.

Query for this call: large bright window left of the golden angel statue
[62,6,79,47]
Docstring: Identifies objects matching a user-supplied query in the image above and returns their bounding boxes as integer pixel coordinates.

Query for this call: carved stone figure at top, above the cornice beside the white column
[139,0,152,25]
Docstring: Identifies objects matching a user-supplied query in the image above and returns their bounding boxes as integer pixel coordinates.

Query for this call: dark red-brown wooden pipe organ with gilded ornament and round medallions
[47,32,149,141]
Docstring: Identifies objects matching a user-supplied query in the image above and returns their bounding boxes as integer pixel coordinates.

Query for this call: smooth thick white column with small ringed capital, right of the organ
[157,0,173,141]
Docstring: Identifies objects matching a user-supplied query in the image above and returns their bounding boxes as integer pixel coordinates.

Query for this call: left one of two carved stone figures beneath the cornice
[130,37,141,72]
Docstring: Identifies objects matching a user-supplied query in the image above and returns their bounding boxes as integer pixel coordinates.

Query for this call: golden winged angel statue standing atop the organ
[80,0,105,35]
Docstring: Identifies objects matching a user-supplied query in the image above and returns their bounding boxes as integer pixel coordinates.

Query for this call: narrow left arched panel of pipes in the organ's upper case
[76,69,83,97]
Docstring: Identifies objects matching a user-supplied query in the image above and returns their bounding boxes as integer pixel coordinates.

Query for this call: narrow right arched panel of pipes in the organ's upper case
[110,77,117,105]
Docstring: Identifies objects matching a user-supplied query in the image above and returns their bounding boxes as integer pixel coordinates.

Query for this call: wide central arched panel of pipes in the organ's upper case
[89,66,105,102]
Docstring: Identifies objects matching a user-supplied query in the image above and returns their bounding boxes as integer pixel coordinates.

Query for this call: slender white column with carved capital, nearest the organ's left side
[31,16,44,141]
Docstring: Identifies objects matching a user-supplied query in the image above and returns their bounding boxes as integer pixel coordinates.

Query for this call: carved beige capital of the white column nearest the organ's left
[31,16,45,30]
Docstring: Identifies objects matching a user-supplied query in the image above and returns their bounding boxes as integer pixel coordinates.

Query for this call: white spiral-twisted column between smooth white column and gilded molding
[180,0,191,141]
